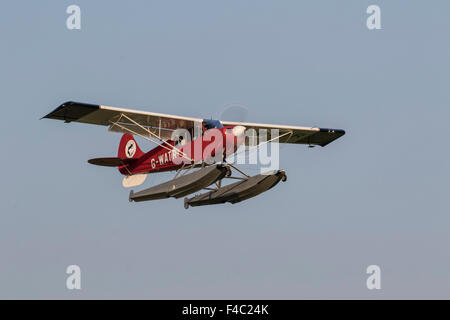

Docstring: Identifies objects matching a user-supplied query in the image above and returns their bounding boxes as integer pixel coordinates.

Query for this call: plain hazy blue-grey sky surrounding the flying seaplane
[0,0,450,299]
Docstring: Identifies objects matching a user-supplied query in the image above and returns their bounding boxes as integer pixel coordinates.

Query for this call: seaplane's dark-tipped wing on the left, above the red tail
[43,101,202,139]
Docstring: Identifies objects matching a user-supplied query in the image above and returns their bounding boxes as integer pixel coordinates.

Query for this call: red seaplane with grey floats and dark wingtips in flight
[43,101,345,209]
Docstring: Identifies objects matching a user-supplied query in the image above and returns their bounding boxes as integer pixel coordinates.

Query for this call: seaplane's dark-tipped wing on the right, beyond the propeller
[221,121,345,147]
